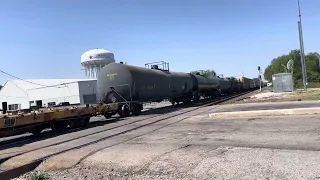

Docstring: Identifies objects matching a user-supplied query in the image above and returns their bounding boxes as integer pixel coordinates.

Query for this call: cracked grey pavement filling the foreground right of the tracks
[42,115,320,179]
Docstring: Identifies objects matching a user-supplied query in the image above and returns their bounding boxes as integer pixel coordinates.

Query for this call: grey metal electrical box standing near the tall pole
[272,73,294,93]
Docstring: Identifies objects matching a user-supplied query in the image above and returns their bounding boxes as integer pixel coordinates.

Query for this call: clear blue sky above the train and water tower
[0,0,320,84]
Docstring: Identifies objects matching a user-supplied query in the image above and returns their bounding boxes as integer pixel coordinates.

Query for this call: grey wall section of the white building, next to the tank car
[78,80,97,104]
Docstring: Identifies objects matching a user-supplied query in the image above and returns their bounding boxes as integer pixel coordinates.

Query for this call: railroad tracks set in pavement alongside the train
[0,91,252,180]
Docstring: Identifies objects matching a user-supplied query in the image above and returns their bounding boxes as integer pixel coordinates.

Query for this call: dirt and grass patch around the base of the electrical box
[224,88,320,104]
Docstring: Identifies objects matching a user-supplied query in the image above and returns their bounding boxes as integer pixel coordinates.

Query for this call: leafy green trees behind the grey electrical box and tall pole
[264,49,320,88]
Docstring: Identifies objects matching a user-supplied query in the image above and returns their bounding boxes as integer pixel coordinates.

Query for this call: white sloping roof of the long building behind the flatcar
[3,79,96,91]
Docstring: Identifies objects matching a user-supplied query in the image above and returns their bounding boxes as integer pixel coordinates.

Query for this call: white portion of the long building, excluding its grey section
[0,79,89,109]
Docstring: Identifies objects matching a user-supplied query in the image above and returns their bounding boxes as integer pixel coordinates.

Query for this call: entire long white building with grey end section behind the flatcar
[0,79,97,110]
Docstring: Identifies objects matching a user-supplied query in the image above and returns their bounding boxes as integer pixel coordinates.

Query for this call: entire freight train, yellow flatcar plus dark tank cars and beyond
[0,62,266,137]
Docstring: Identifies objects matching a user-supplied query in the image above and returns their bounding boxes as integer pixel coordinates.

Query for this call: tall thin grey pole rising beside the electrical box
[298,0,308,91]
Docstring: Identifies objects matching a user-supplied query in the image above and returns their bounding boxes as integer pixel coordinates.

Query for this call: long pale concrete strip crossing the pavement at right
[209,107,320,118]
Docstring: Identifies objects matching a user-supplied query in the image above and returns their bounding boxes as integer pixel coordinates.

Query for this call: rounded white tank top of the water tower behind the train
[81,49,115,64]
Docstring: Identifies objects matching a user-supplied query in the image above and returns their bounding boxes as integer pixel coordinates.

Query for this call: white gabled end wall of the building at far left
[0,81,29,109]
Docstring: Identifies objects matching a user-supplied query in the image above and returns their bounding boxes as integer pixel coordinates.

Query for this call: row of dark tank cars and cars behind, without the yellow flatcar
[97,61,260,118]
